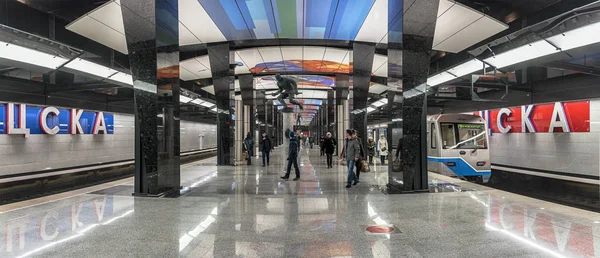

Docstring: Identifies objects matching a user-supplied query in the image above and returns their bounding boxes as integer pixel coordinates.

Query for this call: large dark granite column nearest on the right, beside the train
[388,0,439,192]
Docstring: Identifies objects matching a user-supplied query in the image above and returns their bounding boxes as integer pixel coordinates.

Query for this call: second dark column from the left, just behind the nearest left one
[208,42,235,165]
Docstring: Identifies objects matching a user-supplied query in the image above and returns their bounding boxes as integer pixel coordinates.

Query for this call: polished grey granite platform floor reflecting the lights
[0,146,600,257]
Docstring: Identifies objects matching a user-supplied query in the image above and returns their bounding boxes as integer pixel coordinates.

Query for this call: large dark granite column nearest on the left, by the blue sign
[121,0,181,196]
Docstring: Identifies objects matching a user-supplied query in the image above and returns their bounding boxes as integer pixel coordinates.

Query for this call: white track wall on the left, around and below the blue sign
[0,114,217,176]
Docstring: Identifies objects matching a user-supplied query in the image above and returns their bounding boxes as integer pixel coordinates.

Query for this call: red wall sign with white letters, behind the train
[474,101,590,133]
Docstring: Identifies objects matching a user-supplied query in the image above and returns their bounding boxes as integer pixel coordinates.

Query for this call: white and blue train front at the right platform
[427,114,492,183]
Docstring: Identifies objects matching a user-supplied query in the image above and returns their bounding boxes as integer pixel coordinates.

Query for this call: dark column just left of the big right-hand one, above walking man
[350,42,375,146]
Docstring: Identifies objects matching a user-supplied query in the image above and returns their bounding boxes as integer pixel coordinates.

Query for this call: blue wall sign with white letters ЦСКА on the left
[0,103,115,136]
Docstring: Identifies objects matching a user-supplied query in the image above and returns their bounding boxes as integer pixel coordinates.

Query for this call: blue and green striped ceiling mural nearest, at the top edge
[199,0,375,40]
